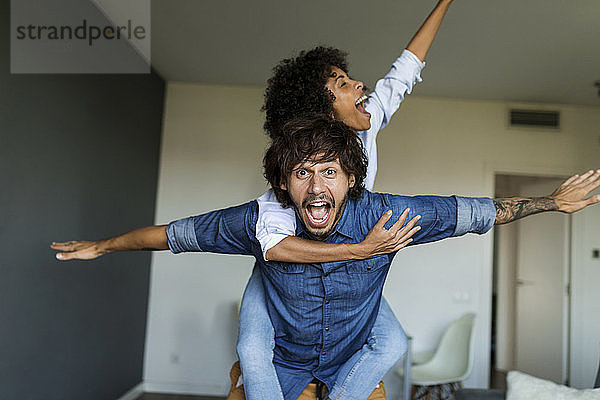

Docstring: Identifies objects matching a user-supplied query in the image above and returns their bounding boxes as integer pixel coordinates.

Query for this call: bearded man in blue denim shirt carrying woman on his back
[52,117,600,400]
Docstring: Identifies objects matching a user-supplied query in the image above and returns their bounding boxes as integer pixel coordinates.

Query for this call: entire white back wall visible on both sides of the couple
[144,83,600,398]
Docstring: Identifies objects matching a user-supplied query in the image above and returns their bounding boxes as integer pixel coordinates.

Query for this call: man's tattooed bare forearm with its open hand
[494,170,600,225]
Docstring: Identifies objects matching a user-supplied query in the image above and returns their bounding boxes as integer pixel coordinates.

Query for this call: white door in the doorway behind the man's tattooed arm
[514,179,570,383]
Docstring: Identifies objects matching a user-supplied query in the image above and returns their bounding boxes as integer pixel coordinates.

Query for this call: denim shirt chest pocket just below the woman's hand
[346,254,390,303]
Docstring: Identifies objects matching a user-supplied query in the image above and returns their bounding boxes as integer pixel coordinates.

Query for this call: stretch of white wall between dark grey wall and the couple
[144,83,266,394]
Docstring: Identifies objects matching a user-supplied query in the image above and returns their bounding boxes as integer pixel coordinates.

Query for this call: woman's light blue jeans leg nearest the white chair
[329,298,408,400]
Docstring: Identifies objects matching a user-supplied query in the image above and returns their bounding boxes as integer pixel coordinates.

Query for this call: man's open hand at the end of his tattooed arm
[548,169,600,214]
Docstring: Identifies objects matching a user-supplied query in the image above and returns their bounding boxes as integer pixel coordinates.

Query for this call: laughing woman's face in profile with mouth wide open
[325,67,371,131]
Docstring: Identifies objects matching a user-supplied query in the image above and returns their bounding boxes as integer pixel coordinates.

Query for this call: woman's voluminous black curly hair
[262,46,348,138]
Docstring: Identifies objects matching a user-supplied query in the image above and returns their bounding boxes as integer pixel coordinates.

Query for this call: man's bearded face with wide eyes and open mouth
[281,156,355,240]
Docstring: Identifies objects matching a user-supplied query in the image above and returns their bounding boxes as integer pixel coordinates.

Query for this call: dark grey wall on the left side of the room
[0,0,164,400]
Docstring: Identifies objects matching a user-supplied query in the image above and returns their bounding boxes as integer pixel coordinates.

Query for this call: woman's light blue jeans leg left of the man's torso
[237,265,283,400]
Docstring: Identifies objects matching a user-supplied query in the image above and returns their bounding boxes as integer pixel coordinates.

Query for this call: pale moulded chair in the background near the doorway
[397,313,475,400]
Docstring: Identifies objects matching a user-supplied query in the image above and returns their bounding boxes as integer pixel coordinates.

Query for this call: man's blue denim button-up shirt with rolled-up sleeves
[167,191,496,400]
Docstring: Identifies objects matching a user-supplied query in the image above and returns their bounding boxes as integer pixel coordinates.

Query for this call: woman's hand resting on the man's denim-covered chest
[358,208,421,258]
